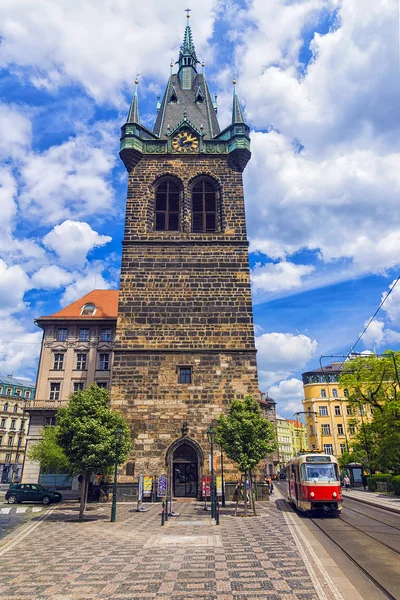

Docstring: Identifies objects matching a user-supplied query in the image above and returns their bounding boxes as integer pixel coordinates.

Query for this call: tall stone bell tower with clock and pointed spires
[111,14,258,496]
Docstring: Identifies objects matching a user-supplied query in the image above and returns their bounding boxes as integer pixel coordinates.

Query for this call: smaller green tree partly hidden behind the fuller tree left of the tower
[28,427,70,486]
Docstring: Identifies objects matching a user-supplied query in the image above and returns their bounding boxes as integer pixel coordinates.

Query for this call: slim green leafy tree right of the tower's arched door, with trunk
[217,396,276,514]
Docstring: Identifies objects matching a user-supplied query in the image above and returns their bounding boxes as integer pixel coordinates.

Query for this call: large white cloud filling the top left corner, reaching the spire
[0,0,217,104]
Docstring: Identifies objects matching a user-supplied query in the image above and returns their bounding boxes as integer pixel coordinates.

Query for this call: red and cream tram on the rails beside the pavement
[286,454,343,514]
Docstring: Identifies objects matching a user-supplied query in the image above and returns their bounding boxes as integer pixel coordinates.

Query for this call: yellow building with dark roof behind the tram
[302,362,372,457]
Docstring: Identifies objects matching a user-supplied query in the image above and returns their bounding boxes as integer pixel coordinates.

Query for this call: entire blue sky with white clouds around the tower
[0,0,400,416]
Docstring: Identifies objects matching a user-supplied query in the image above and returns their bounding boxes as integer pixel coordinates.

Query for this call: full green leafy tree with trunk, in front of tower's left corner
[57,384,131,520]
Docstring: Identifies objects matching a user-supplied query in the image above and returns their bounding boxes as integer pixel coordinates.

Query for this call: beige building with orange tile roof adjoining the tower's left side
[22,290,118,483]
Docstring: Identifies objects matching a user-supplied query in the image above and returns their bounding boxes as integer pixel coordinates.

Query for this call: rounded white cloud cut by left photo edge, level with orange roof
[0,258,30,317]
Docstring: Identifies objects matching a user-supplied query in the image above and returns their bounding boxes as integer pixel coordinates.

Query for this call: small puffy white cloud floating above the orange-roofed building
[43,220,112,266]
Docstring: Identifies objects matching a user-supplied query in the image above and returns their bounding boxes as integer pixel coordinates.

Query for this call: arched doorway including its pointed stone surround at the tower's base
[166,437,204,498]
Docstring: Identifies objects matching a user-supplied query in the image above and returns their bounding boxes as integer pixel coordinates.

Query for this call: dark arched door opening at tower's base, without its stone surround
[172,443,199,498]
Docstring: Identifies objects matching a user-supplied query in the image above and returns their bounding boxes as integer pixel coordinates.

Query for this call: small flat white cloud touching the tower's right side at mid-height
[251,261,314,293]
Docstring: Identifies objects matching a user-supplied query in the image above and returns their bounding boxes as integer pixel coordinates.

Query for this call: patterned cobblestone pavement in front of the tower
[0,502,342,600]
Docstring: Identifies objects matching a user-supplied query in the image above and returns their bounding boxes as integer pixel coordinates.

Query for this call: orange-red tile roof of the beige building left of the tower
[38,290,119,320]
